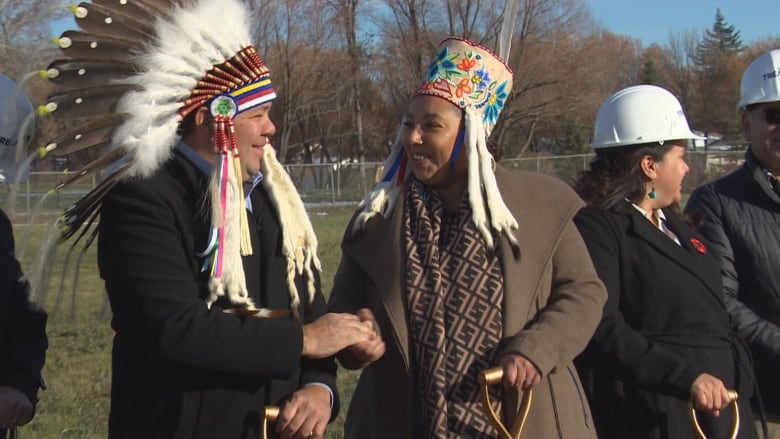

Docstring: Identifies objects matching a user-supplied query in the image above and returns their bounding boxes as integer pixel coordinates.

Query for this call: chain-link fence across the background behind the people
[0,151,745,222]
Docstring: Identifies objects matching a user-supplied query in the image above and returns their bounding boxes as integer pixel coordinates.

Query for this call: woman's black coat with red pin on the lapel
[575,206,756,439]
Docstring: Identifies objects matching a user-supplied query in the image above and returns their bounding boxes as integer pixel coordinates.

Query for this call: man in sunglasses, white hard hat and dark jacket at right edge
[686,49,780,438]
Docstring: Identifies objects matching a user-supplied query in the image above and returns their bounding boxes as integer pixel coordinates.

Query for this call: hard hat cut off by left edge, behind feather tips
[0,73,35,182]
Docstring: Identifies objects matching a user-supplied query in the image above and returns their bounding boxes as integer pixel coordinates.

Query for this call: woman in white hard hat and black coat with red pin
[574,85,756,439]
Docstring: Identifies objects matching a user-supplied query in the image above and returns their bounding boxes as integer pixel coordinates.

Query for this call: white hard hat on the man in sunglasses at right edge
[739,49,780,108]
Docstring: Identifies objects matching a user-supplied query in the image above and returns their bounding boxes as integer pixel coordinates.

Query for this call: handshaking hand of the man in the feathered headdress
[303,313,376,358]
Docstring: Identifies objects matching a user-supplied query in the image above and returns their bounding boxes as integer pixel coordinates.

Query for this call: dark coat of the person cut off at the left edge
[0,210,48,437]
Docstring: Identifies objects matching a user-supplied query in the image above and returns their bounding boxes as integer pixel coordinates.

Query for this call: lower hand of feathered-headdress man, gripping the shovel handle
[276,386,331,439]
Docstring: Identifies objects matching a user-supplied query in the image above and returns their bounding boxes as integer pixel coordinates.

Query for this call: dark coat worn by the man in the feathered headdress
[98,153,338,439]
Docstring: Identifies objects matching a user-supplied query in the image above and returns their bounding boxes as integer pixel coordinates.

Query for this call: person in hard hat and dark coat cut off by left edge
[0,74,48,438]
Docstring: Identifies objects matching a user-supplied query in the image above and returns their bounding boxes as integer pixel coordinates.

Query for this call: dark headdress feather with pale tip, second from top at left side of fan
[54,30,143,62]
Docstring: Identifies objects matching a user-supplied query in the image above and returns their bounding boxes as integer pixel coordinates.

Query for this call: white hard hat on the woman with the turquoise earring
[590,85,704,149]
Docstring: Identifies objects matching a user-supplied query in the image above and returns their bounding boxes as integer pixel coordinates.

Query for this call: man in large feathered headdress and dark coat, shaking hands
[42,0,376,439]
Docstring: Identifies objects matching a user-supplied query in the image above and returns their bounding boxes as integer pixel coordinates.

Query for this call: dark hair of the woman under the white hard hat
[574,142,679,211]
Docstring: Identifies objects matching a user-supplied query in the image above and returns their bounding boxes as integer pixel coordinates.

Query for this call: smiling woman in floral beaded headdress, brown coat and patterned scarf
[329,34,606,438]
